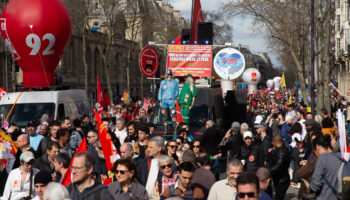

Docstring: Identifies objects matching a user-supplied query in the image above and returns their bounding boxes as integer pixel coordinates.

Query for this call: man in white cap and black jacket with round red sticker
[240,131,264,172]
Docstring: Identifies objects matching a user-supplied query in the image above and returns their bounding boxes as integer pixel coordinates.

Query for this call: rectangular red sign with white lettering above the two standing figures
[168,45,212,77]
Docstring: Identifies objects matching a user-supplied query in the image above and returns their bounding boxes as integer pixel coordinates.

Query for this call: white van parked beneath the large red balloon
[0,90,89,127]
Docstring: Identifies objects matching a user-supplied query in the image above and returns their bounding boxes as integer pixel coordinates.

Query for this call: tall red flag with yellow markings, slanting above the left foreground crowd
[94,110,120,185]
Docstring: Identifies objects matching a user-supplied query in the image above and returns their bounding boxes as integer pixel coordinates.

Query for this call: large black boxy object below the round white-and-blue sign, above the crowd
[224,90,247,130]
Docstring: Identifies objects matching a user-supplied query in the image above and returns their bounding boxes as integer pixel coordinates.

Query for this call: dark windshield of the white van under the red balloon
[0,103,55,128]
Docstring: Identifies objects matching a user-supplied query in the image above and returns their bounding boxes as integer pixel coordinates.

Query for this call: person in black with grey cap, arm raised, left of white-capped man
[219,122,243,162]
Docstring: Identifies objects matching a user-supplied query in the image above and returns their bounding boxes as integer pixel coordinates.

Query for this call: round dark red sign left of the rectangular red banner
[139,47,159,78]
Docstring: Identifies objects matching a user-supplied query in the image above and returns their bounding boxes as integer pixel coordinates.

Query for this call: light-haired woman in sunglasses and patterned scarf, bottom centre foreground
[150,155,177,199]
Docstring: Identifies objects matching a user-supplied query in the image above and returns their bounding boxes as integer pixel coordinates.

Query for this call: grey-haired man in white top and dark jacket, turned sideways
[137,136,165,194]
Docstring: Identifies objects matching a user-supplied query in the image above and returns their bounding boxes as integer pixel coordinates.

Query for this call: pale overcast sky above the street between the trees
[167,0,280,67]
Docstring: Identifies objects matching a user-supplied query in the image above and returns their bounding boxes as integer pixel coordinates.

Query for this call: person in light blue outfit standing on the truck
[158,70,179,124]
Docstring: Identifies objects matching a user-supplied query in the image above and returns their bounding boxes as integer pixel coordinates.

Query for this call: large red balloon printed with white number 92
[0,0,72,88]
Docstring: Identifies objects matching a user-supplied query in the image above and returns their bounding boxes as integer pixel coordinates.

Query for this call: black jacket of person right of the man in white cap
[267,145,290,183]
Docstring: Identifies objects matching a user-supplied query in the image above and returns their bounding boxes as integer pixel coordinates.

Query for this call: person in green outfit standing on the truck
[179,74,197,124]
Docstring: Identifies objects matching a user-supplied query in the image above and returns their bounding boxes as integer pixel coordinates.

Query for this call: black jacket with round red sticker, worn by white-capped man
[240,144,264,172]
